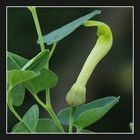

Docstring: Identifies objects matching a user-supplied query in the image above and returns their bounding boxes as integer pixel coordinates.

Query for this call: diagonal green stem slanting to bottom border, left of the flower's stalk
[34,95,64,132]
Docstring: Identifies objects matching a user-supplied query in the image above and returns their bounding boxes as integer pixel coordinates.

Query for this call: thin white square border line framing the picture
[6,6,135,135]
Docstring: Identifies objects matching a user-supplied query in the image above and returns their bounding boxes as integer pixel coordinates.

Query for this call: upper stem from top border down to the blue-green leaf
[28,6,45,51]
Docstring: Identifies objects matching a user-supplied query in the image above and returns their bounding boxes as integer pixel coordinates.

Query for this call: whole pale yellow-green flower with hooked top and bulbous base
[66,20,113,106]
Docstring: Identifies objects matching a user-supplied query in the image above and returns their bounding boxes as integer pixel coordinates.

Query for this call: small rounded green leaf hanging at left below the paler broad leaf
[10,84,25,106]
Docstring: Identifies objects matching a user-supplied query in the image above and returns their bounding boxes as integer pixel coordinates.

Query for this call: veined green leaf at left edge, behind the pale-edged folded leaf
[7,52,29,70]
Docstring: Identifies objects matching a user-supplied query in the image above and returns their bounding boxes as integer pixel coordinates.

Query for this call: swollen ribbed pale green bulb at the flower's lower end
[66,83,86,107]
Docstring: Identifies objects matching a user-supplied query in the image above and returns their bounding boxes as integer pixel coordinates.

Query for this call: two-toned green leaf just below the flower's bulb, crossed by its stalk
[58,96,119,128]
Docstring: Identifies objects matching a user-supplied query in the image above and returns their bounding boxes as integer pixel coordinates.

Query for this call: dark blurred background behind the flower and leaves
[7,7,133,132]
